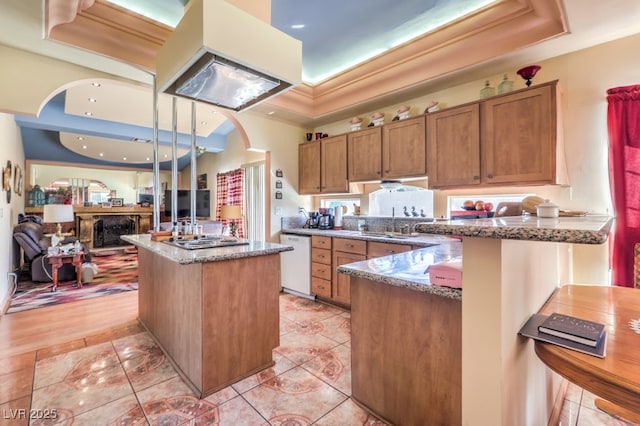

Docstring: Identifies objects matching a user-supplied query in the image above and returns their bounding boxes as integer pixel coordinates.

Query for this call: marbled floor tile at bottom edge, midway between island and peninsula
[243,367,347,425]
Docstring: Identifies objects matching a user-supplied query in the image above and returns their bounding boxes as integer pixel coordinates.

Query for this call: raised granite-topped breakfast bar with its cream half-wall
[415,215,614,425]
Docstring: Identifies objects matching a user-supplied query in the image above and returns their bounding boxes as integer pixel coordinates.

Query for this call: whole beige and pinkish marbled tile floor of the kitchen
[0,294,629,426]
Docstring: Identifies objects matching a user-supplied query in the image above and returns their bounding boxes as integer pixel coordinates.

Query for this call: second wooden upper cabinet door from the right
[427,104,480,188]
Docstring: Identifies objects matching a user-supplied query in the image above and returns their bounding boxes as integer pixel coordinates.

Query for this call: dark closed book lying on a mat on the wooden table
[538,312,604,347]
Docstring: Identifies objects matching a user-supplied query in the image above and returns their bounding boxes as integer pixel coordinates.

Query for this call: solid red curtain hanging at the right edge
[607,85,640,287]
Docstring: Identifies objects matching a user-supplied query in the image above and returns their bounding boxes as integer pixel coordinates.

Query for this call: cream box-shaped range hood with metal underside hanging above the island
[156,0,302,111]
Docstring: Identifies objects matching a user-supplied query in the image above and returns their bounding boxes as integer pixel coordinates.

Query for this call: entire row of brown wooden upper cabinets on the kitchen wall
[299,81,567,194]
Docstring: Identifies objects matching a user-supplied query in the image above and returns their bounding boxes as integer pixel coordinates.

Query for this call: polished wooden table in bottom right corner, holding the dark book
[535,285,640,423]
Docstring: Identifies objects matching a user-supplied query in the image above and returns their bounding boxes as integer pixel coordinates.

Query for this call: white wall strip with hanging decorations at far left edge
[0,113,26,312]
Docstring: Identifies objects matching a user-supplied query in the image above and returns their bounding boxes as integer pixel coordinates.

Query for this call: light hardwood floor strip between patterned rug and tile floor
[0,291,138,359]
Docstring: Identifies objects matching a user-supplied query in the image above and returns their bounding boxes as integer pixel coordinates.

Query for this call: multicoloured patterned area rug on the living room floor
[6,252,138,314]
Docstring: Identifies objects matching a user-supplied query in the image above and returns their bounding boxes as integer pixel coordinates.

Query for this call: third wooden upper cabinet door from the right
[382,115,427,178]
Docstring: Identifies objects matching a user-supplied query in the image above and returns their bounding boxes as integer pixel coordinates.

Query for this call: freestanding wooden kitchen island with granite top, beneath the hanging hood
[122,235,292,397]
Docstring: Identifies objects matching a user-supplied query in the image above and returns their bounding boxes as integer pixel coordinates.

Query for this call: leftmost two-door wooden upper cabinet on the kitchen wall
[298,135,349,194]
